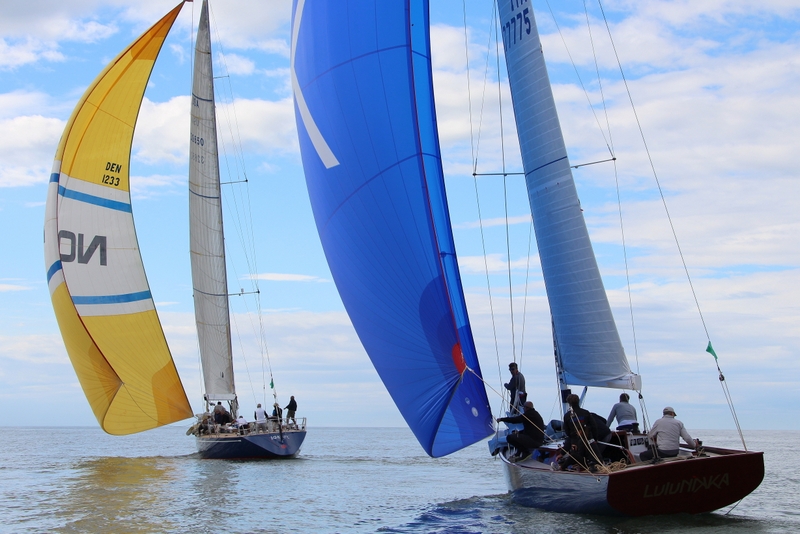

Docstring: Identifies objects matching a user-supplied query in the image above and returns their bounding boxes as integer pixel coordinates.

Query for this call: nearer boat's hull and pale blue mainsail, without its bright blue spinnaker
[490,1,764,516]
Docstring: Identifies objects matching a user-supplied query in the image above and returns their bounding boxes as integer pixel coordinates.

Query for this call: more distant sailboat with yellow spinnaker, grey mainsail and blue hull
[44,2,305,458]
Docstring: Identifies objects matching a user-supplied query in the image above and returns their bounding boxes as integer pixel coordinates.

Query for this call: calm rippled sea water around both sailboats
[0,426,800,534]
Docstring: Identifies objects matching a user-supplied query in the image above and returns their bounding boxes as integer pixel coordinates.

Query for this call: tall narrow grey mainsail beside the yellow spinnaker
[189,0,238,416]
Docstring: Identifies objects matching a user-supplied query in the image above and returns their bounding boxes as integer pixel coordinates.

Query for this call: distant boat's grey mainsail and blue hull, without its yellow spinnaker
[189,0,306,458]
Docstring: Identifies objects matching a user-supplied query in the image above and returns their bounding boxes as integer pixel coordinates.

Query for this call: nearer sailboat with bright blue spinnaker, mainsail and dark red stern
[291,0,764,516]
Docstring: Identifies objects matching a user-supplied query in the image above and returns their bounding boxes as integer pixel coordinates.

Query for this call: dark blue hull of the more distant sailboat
[196,430,306,460]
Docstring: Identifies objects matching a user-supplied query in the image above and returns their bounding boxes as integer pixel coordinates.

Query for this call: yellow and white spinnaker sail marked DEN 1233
[45,2,192,434]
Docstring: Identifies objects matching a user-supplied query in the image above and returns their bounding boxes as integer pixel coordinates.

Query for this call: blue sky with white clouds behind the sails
[0,0,800,437]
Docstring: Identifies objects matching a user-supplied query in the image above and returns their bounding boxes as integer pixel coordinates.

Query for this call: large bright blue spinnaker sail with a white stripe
[292,0,493,456]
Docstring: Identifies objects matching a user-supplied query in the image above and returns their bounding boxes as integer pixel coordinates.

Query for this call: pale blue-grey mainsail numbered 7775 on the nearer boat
[497,0,641,390]
